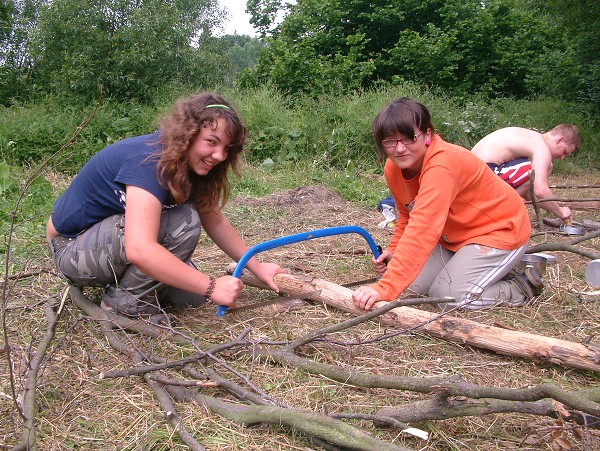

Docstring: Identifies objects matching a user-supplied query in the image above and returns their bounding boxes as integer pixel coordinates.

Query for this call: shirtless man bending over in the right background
[472,124,579,223]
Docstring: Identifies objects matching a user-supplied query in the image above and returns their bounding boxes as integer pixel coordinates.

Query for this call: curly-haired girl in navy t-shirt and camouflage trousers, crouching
[46,92,285,316]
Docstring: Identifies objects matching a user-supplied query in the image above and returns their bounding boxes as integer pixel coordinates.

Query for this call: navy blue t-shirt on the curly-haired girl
[52,132,175,237]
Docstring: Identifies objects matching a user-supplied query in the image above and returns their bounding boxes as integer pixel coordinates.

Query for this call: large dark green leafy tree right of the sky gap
[246,0,571,101]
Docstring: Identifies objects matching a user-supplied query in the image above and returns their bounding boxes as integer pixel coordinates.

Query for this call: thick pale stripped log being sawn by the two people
[233,271,600,371]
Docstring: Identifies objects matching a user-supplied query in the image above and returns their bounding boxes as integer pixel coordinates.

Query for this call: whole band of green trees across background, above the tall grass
[0,0,600,112]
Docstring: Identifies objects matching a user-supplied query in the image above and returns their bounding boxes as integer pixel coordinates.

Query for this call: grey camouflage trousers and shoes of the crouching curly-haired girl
[49,204,206,316]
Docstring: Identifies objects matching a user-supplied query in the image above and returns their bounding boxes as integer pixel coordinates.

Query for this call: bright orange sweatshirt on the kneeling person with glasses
[371,135,531,301]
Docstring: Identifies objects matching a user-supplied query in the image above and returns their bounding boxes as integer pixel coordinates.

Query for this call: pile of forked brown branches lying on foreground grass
[5,278,600,450]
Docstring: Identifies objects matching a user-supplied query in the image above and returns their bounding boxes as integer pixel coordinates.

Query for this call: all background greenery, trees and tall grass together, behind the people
[0,0,600,175]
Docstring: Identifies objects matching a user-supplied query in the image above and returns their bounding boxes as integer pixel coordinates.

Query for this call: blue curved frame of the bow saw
[217,225,381,316]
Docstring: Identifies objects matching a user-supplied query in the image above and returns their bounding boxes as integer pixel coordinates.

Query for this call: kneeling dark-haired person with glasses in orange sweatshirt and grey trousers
[352,98,543,310]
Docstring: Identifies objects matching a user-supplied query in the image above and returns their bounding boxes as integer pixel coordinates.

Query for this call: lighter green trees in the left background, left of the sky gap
[0,0,261,106]
